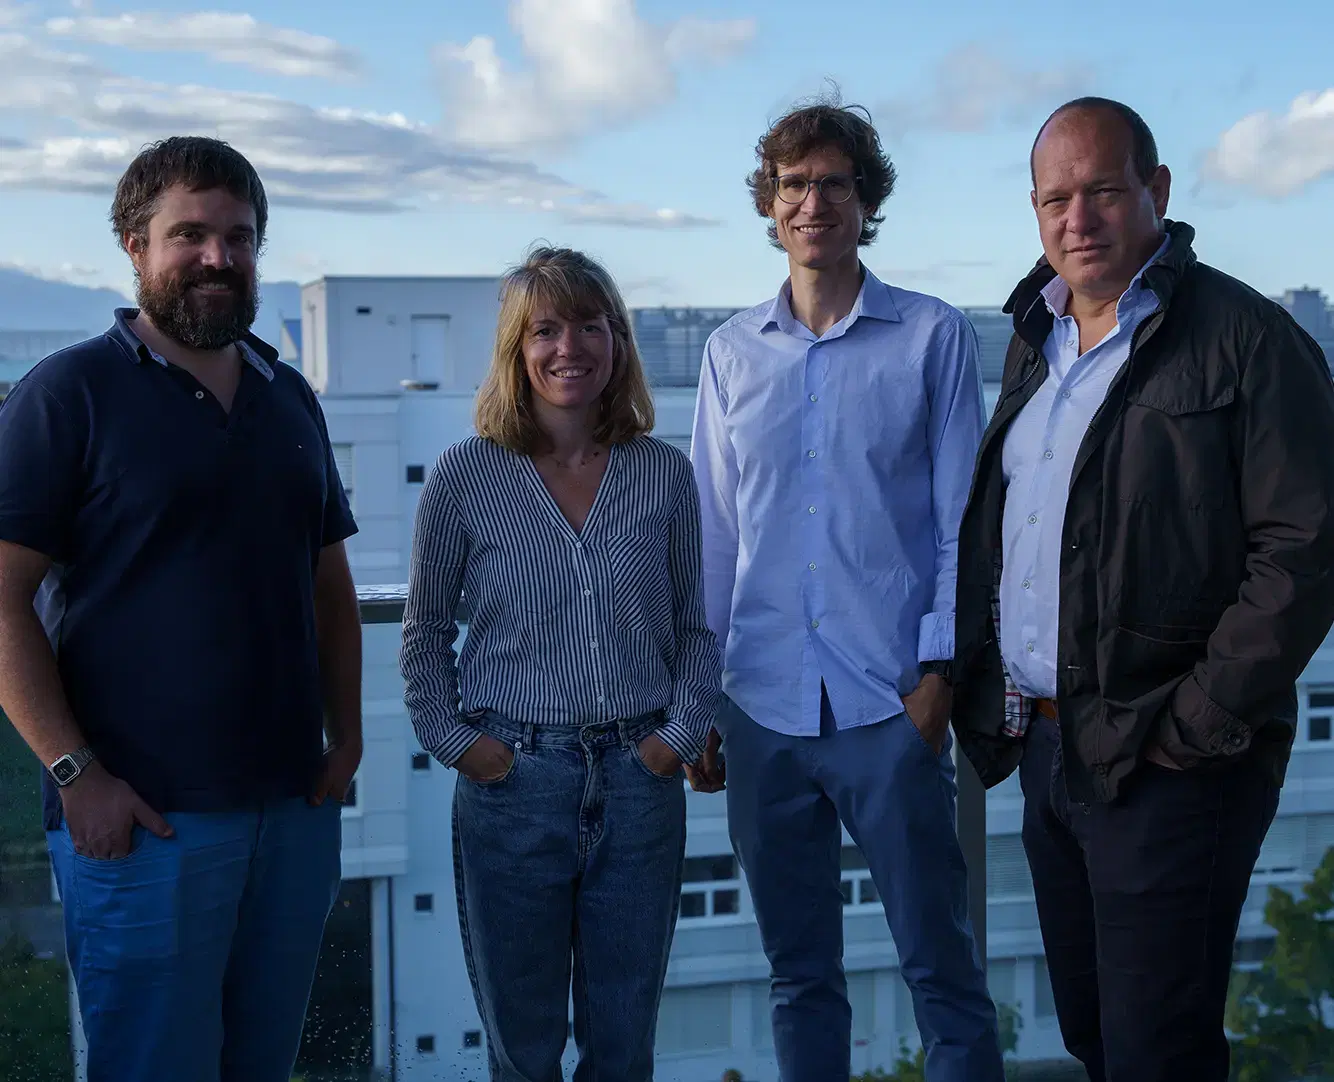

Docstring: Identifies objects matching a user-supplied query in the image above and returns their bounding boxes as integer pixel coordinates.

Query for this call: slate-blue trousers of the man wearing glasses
[718,698,1005,1082]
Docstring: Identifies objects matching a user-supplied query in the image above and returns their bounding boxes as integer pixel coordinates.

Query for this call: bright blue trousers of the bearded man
[47,799,342,1082]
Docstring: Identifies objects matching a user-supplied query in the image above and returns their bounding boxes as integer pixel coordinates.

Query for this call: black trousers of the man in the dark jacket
[1019,718,1278,1082]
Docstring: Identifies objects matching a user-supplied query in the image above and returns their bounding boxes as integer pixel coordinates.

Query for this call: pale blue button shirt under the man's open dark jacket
[1001,240,1167,699]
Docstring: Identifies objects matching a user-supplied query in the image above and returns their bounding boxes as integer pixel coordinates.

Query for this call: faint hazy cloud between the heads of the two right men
[876,44,1087,132]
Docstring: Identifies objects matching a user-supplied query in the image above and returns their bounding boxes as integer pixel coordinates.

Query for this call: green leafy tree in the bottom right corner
[1227,849,1334,1082]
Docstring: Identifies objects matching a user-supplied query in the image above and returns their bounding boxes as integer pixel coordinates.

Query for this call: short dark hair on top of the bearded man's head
[111,135,268,251]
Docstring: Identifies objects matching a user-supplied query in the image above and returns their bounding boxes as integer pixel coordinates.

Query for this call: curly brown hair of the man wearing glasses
[746,96,895,248]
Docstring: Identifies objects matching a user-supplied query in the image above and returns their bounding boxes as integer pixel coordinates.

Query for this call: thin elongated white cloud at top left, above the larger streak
[47,11,362,79]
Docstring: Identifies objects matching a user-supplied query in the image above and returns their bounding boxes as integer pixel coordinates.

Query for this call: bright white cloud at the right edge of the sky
[1202,88,1334,199]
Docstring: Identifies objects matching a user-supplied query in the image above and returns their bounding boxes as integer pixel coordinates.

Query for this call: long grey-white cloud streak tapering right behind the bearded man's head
[0,33,710,228]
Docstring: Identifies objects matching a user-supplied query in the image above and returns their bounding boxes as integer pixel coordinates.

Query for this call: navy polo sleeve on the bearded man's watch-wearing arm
[0,376,87,563]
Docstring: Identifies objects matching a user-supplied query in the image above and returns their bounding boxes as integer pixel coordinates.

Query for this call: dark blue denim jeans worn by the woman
[454,714,686,1082]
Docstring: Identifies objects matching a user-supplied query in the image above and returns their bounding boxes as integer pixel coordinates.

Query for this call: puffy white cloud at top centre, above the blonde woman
[436,0,755,148]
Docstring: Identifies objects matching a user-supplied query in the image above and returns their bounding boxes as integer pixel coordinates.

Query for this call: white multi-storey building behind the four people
[300,278,1334,1082]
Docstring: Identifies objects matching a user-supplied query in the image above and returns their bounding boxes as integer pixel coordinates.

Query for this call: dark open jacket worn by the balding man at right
[954,223,1334,803]
